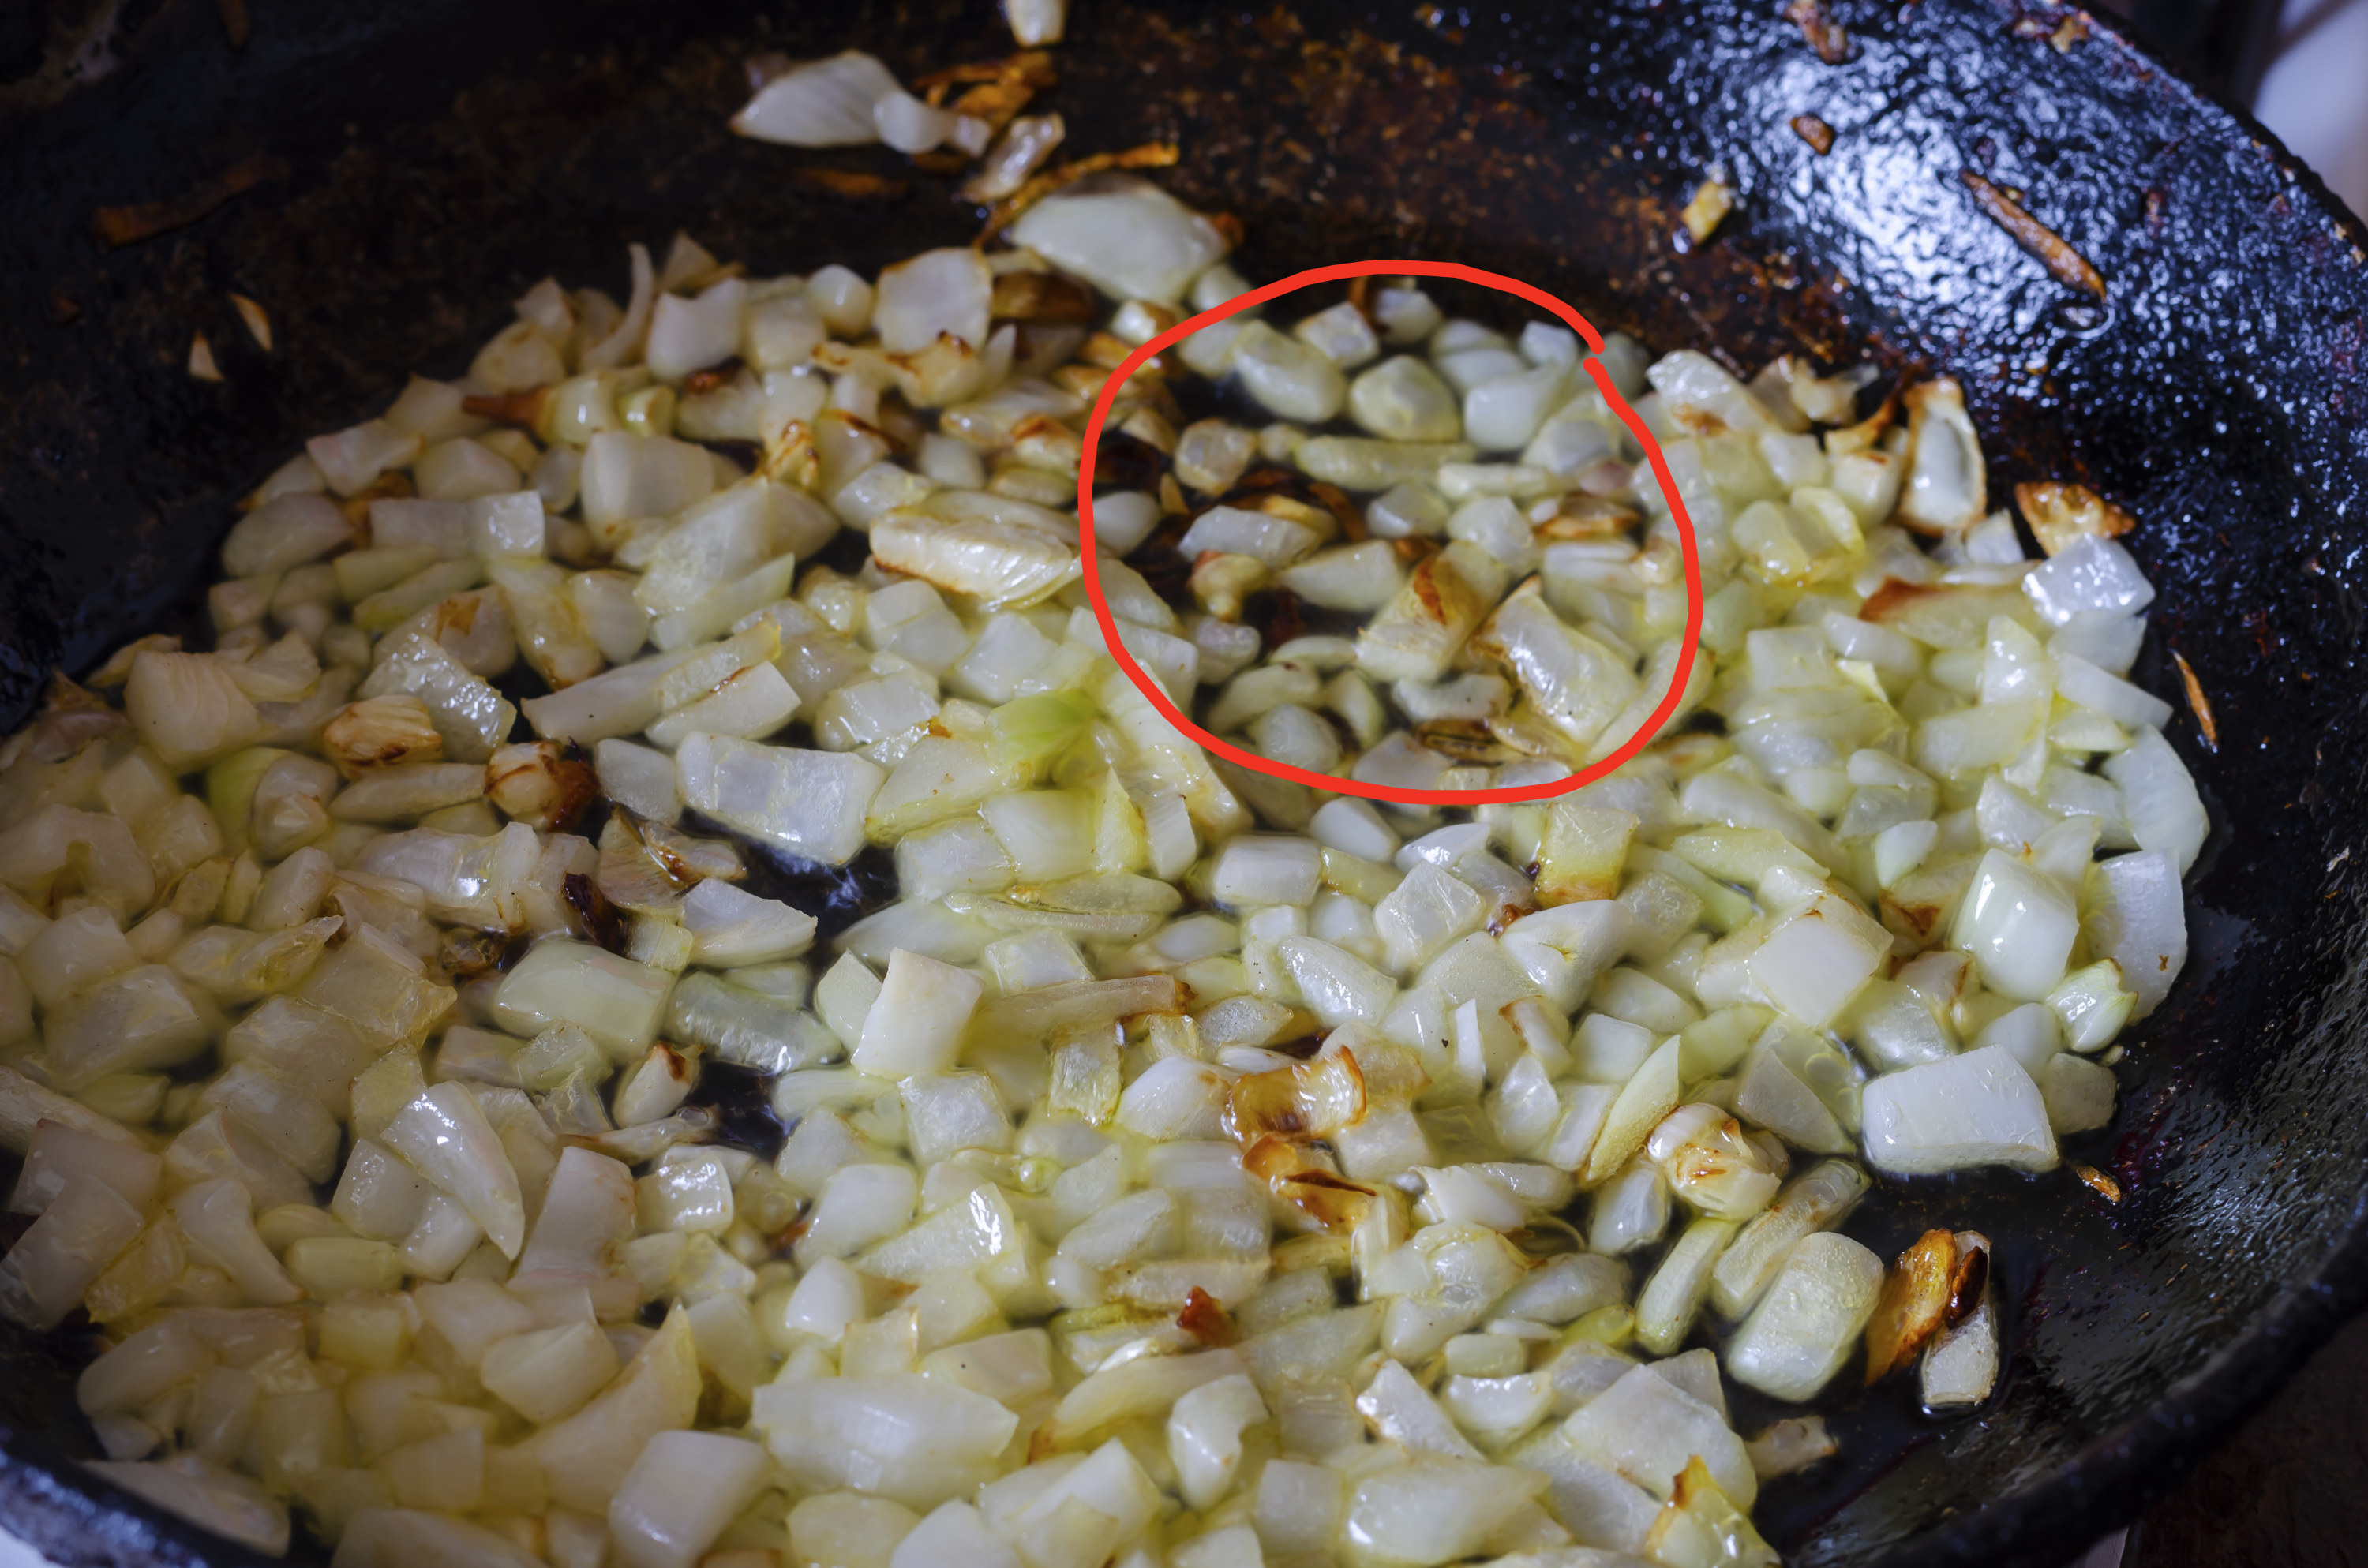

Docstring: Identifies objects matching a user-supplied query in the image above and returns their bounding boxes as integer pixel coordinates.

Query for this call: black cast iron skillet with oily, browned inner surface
[0,0,2368,1563]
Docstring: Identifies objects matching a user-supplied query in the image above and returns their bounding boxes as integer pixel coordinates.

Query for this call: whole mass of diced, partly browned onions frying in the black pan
[0,162,2207,1568]
